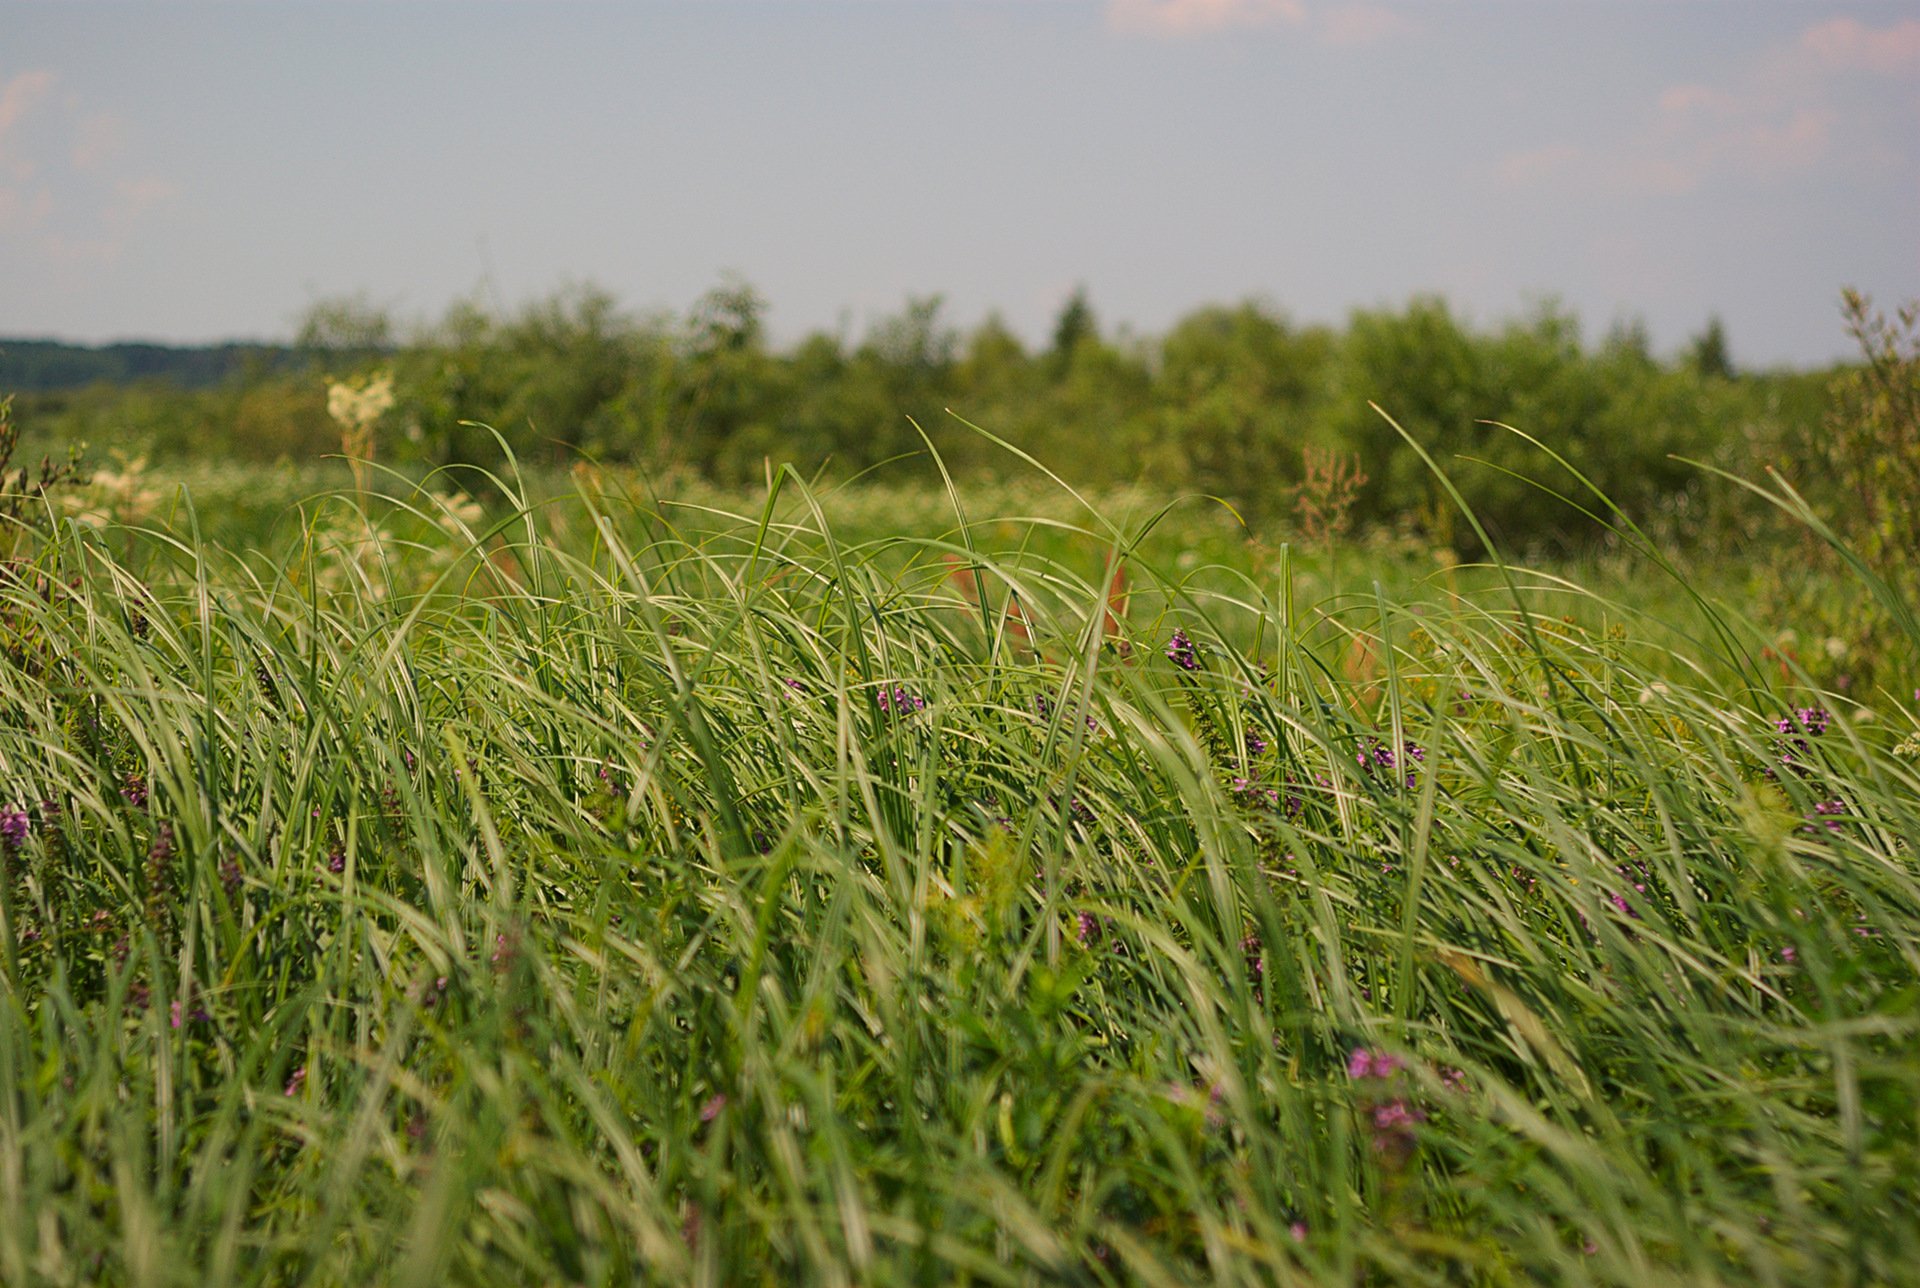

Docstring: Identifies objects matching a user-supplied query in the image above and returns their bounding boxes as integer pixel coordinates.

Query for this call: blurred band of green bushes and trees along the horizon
[0,286,1826,553]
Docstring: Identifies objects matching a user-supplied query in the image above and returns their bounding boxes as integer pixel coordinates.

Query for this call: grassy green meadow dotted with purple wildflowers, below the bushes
[0,445,1920,1286]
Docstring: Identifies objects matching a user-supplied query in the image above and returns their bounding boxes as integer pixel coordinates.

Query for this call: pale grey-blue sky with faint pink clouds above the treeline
[0,0,1920,367]
